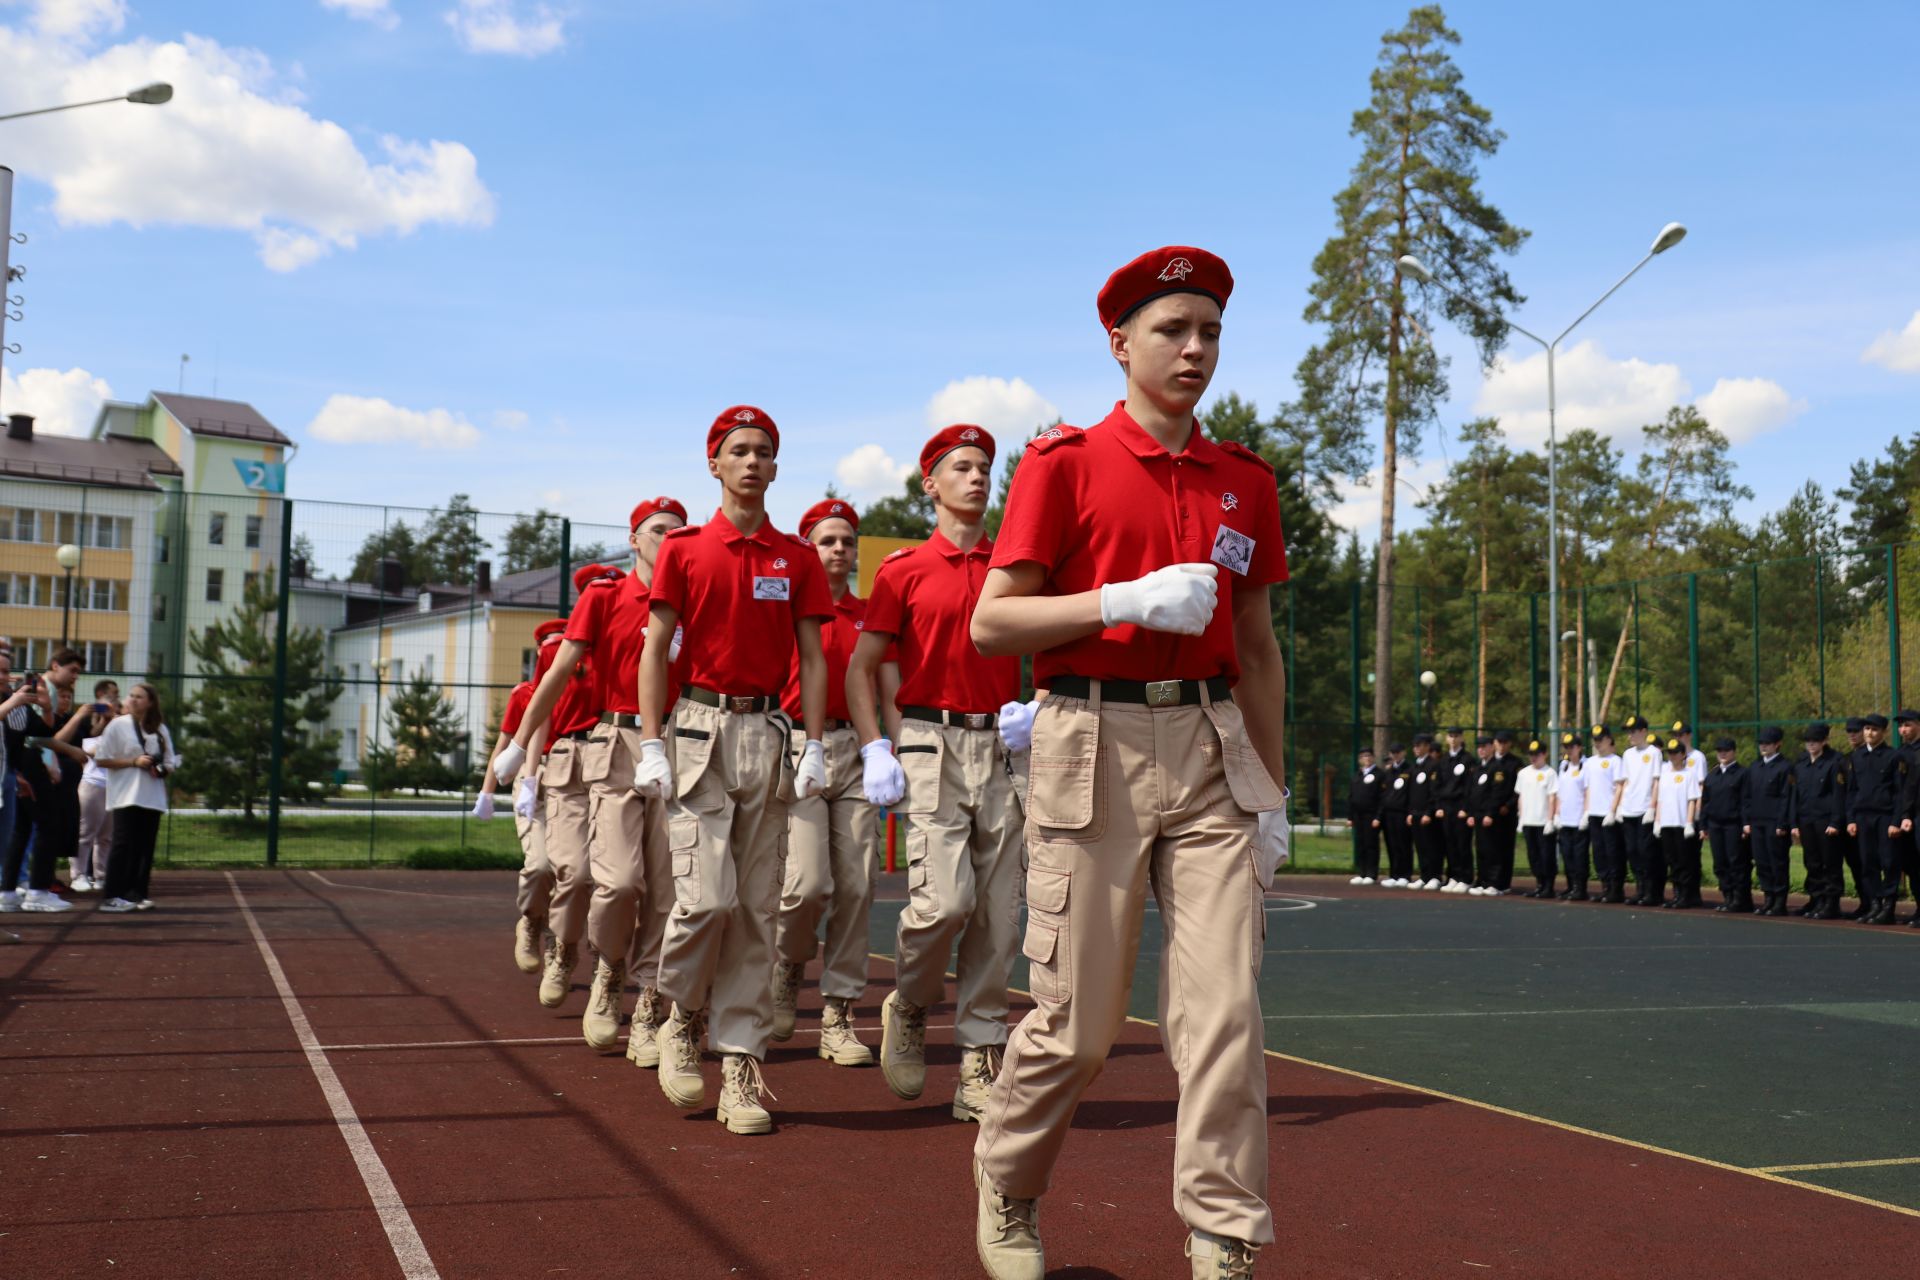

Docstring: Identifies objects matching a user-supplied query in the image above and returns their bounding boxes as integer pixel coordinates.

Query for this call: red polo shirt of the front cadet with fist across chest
[990,405,1286,689]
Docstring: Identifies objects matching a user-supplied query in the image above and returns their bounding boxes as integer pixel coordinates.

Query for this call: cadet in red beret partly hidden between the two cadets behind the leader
[772,497,899,1067]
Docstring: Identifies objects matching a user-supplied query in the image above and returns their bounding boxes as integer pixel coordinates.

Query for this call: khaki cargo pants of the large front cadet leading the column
[973,685,1281,1244]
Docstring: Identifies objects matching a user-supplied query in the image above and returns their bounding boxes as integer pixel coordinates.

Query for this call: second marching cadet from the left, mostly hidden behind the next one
[493,564,624,1009]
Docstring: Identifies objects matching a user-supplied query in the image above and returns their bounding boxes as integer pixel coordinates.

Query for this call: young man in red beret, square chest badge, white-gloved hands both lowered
[634,405,835,1134]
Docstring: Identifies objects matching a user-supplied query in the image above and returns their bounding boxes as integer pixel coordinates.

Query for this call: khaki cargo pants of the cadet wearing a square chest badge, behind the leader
[660,699,793,1059]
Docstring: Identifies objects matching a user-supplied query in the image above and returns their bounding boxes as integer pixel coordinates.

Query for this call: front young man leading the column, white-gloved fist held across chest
[973,248,1286,1280]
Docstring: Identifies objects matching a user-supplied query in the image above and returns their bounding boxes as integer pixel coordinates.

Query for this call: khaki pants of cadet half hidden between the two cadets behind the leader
[774,725,879,1000]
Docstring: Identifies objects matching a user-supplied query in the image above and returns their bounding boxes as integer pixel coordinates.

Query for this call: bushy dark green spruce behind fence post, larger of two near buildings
[179,568,342,818]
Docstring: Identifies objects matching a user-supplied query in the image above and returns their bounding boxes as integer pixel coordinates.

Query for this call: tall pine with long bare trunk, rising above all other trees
[1296,6,1526,750]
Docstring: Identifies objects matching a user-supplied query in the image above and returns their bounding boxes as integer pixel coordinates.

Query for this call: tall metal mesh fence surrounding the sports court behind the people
[0,478,1920,865]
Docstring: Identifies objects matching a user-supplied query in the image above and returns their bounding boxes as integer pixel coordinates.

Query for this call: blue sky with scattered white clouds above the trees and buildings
[0,0,1920,560]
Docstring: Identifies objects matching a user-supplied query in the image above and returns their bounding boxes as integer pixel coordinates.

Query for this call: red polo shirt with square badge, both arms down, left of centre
[653,510,835,697]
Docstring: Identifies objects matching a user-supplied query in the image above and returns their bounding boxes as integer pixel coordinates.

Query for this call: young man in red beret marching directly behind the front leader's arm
[847,426,1029,1121]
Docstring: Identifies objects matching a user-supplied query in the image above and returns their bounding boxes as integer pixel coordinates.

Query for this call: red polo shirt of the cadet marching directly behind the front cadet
[866,530,1020,712]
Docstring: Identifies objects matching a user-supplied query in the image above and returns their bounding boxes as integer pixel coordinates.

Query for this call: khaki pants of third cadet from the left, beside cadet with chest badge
[580,723,674,986]
